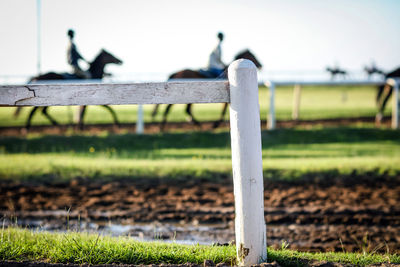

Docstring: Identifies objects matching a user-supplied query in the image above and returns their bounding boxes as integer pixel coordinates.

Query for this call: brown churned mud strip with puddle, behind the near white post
[0,175,400,253]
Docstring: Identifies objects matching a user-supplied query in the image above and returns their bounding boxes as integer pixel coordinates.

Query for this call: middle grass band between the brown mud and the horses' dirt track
[0,128,400,181]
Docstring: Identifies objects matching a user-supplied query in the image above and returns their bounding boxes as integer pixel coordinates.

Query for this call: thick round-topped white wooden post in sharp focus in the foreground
[228,59,267,266]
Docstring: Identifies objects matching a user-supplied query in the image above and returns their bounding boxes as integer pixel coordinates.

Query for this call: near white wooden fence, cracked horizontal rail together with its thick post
[0,59,267,265]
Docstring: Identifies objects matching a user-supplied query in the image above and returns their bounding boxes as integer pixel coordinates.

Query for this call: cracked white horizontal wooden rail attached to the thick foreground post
[0,81,229,106]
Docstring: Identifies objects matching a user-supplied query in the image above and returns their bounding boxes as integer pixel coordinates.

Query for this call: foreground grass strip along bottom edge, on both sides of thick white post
[0,228,400,266]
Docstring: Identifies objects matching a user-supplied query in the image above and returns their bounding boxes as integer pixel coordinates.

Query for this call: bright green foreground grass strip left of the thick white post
[0,228,235,264]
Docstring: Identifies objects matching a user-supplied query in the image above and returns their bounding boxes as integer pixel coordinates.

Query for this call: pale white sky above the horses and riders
[0,0,400,79]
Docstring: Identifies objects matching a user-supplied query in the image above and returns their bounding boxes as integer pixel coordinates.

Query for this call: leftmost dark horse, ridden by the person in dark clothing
[14,49,122,130]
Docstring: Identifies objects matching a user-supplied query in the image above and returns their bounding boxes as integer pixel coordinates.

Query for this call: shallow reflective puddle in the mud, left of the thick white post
[3,219,235,245]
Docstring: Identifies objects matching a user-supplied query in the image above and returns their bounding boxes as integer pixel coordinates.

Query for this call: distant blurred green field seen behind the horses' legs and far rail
[0,86,391,126]
